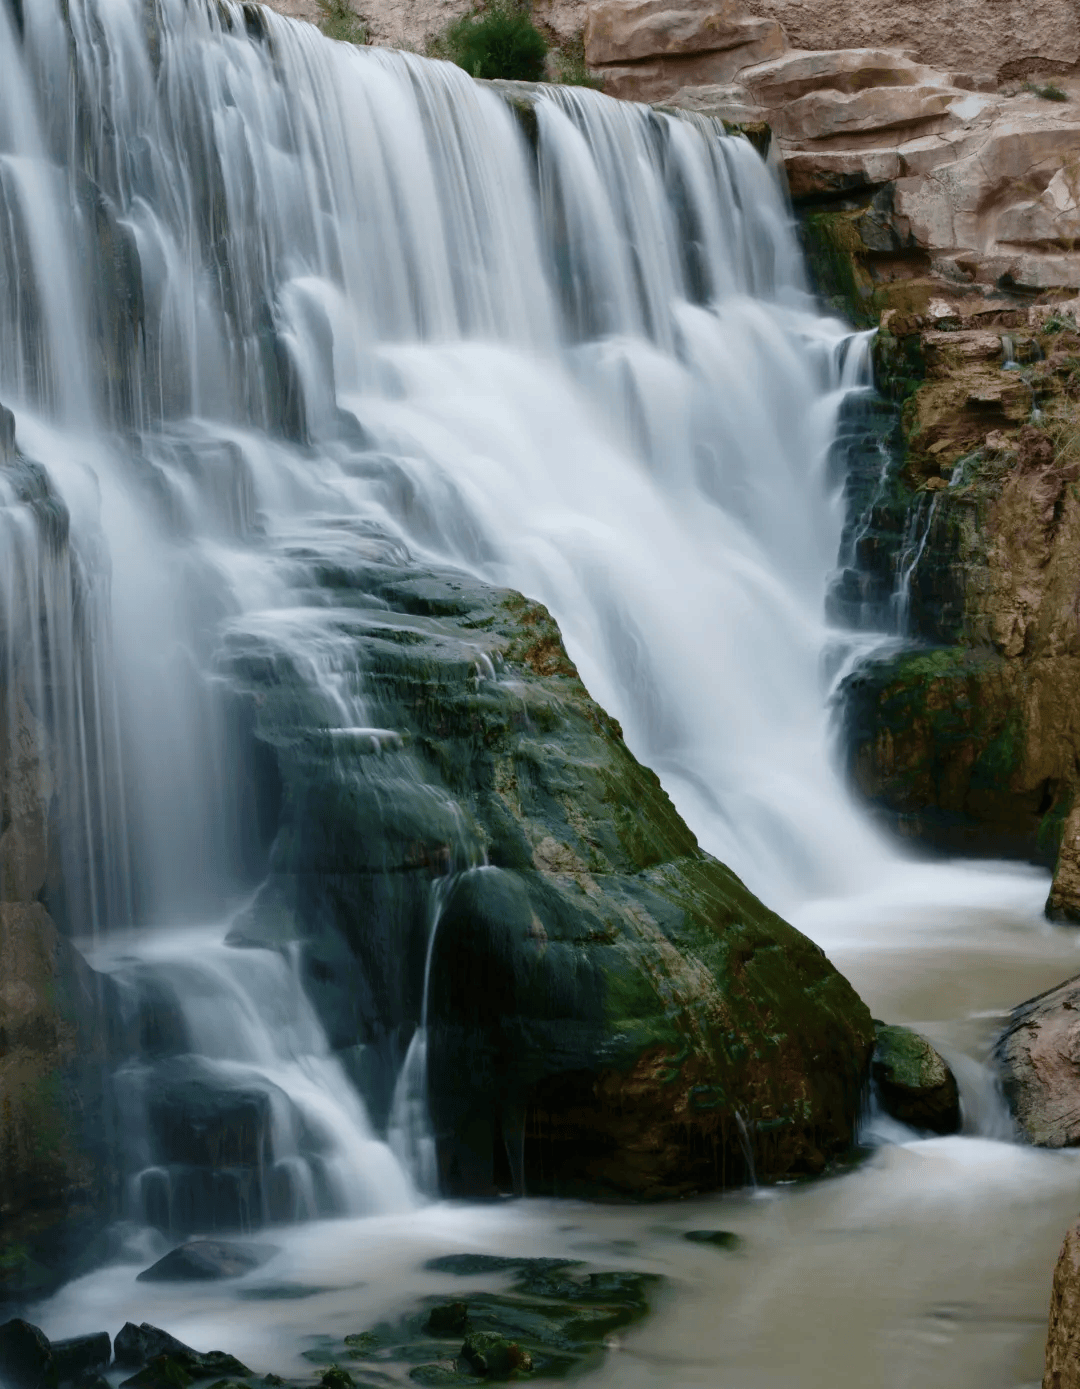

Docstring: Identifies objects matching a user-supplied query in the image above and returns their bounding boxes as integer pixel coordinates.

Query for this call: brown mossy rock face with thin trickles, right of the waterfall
[838,290,1080,921]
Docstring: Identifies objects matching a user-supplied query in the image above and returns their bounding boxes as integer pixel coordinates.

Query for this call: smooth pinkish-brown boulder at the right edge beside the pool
[995,976,1080,1147]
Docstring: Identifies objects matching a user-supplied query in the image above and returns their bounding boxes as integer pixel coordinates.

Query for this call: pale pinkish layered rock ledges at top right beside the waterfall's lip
[665,47,1080,295]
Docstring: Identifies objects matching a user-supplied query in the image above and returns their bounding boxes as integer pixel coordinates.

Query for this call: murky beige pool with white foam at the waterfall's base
[33,863,1080,1389]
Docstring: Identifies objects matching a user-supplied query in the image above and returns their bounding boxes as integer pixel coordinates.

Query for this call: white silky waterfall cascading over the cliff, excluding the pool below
[0,0,887,1213]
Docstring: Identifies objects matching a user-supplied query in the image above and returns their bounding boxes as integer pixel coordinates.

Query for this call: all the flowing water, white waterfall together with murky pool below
[0,0,1077,1389]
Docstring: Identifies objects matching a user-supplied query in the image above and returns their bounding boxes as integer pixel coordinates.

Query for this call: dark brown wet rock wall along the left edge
[0,406,117,1304]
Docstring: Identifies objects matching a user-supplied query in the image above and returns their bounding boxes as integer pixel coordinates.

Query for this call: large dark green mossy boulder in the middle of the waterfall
[229,554,872,1196]
